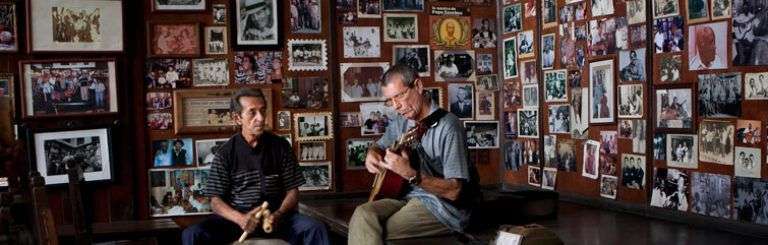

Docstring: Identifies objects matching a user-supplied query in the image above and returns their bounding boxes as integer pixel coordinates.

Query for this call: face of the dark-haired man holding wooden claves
[234,97,267,136]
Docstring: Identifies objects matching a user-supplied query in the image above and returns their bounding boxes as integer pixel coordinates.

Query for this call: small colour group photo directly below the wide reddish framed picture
[144,59,192,89]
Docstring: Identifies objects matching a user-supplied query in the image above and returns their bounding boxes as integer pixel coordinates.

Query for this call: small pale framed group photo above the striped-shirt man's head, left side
[192,59,229,87]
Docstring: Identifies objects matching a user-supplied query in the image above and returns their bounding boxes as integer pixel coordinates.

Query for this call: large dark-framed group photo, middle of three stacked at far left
[19,59,117,117]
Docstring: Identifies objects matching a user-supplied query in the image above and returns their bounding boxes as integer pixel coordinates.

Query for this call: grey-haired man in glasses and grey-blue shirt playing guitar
[348,64,479,244]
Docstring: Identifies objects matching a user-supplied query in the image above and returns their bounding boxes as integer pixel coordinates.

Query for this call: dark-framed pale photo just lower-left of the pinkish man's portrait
[656,88,693,128]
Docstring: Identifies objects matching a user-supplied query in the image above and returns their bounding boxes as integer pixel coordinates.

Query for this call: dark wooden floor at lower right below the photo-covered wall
[536,202,768,245]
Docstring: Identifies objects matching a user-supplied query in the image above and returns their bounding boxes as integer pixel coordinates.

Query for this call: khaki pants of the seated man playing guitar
[348,198,451,245]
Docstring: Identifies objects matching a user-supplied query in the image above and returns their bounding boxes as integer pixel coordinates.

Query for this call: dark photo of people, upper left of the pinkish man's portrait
[653,16,686,54]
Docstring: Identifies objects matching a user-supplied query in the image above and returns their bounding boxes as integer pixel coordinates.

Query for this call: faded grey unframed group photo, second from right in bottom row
[691,172,732,219]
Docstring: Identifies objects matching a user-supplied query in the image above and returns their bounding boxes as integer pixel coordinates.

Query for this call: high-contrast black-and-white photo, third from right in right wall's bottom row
[651,168,690,211]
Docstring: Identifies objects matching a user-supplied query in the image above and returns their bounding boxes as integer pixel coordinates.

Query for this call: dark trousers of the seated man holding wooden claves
[181,213,329,245]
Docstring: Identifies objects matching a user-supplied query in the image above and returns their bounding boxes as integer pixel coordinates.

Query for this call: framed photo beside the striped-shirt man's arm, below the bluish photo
[148,167,213,217]
